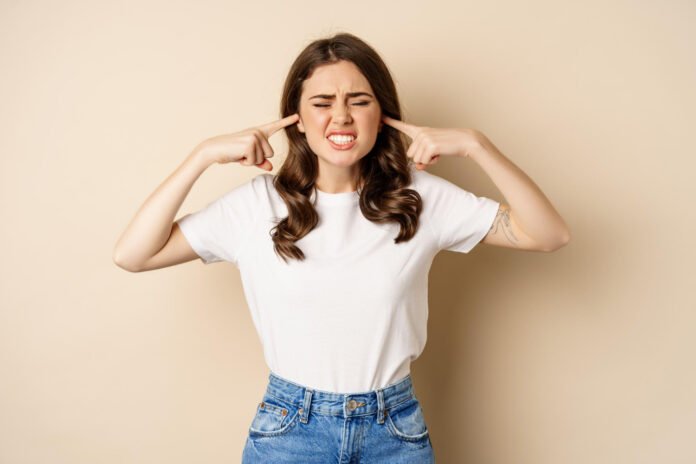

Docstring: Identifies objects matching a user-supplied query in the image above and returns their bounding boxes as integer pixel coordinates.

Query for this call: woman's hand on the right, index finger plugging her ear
[382,115,482,170]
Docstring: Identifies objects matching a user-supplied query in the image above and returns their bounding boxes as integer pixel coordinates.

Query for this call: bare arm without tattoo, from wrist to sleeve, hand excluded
[113,144,214,272]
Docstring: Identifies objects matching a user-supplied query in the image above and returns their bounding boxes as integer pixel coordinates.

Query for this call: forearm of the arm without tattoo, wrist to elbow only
[113,145,211,270]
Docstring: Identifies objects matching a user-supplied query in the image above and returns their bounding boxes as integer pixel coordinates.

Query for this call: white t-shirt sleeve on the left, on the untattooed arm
[176,175,263,265]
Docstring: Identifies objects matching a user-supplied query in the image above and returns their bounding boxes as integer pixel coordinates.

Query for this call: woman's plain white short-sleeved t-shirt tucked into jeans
[177,165,500,393]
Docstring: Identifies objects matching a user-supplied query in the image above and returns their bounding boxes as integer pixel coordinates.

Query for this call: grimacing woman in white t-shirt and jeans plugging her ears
[114,33,569,464]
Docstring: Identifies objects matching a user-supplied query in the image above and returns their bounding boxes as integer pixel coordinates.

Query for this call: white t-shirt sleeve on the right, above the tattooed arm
[416,171,500,253]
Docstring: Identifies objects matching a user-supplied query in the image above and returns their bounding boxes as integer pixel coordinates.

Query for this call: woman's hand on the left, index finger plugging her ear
[201,113,300,171]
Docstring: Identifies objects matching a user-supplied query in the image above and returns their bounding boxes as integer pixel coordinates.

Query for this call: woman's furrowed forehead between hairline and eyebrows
[302,61,372,95]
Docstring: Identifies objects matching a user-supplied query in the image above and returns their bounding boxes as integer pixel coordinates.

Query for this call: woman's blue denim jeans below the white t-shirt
[242,372,435,464]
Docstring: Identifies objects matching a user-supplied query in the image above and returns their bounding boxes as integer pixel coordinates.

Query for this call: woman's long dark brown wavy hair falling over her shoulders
[270,32,423,263]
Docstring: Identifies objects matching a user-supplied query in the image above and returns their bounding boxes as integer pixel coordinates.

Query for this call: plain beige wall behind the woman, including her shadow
[0,0,696,464]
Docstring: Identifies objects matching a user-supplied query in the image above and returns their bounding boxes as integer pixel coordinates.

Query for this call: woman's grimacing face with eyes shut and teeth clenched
[297,61,382,171]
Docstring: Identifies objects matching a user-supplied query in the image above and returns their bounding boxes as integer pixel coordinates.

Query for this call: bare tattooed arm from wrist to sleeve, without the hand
[460,129,570,251]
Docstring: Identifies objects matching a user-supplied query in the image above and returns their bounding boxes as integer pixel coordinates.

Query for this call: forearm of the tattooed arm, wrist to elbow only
[469,133,570,248]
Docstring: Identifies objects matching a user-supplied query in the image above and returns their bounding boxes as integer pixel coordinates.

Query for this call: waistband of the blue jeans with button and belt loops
[266,372,415,423]
